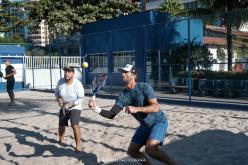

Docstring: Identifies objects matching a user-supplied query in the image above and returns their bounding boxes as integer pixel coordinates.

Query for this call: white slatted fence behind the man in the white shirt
[24,56,83,91]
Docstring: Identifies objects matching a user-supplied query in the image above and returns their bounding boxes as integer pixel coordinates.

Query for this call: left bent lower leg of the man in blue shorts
[127,142,151,165]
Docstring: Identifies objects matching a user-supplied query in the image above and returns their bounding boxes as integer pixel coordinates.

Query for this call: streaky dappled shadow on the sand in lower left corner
[0,127,100,165]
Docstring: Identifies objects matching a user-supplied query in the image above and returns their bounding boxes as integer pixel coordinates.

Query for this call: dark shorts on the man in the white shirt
[59,109,81,126]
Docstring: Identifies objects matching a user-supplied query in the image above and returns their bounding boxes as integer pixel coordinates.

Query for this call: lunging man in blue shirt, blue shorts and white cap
[88,64,176,165]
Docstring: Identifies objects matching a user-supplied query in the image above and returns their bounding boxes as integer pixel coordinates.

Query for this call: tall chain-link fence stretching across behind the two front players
[0,10,248,103]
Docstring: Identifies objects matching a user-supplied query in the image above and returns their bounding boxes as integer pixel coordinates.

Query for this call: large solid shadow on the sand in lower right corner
[107,130,248,165]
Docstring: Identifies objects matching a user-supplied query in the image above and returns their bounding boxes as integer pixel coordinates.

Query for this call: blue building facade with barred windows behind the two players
[80,11,203,86]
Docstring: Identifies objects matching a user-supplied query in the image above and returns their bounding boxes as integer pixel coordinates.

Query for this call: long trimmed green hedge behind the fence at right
[177,70,248,80]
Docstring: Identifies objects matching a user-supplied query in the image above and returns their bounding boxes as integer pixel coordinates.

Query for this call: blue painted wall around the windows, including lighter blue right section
[81,11,203,85]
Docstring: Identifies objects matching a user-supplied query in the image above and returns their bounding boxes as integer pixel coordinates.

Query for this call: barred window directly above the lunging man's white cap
[112,51,135,73]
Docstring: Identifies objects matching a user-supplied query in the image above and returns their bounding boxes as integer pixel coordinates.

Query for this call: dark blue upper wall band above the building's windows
[81,11,168,56]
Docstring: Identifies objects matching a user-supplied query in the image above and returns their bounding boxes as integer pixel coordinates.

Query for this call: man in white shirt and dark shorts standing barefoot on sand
[55,66,84,151]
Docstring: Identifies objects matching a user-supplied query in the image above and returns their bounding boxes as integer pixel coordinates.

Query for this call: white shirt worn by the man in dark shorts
[55,78,84,110]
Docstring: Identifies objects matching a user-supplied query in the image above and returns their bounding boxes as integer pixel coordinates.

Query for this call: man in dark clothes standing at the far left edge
[3,59,16,106]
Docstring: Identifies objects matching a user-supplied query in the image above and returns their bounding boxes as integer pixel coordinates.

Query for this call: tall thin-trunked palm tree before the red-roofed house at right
[177,0,248,71]
